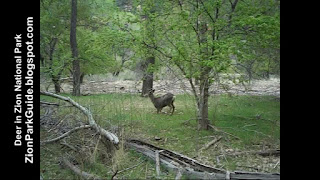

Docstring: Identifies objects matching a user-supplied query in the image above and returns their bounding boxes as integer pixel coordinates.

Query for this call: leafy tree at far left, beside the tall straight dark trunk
[40,0,70,93]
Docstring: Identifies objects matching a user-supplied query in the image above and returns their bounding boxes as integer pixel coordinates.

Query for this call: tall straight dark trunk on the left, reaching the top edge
[70,0,80,96]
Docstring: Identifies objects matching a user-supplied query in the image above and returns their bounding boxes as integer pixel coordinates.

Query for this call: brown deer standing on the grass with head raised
[148,89,175,115]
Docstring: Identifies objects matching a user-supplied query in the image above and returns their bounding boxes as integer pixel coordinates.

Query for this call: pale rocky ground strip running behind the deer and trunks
[41,78,280,97]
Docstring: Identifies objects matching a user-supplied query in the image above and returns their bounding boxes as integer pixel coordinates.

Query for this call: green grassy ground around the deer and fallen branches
[40,94,280,179]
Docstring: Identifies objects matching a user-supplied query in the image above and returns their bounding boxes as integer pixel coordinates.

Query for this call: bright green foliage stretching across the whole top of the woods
[40,0,280,80]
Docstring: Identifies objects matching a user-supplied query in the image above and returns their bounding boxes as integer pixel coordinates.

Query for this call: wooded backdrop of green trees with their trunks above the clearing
[40,0,280,129]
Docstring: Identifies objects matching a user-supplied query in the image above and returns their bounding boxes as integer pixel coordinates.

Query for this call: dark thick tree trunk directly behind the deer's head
[141,57,155,96]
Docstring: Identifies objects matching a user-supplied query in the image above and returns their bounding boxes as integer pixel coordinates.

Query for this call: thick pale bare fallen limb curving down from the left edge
[40,91,119,145]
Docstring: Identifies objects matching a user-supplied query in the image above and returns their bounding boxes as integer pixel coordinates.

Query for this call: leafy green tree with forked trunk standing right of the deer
[138,0,270,129]
